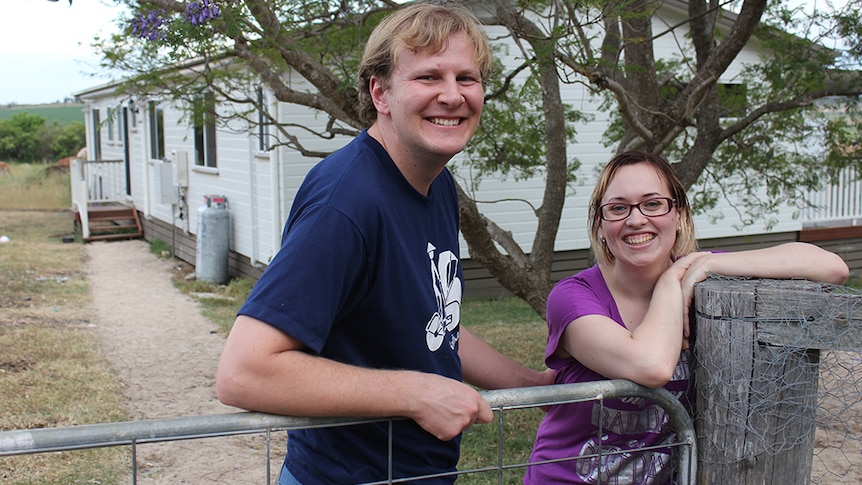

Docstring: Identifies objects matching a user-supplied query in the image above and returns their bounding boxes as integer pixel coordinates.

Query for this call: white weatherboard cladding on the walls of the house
[76,1,802,284]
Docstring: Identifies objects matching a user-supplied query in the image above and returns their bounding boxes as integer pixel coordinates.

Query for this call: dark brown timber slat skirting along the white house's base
[142,214,862,299]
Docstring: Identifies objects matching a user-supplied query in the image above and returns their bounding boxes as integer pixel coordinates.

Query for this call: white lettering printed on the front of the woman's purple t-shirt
[575,351,691,485]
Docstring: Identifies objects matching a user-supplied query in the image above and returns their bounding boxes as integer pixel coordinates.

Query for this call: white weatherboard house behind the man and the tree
[73,1,858,294]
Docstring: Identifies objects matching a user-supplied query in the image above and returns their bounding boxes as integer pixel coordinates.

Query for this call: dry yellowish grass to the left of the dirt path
[0,208,129,484]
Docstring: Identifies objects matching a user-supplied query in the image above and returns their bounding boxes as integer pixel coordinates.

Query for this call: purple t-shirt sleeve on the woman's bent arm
[545,267,618,359]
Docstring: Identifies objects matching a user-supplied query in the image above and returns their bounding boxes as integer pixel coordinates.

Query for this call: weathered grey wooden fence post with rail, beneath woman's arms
[693,277,862,485]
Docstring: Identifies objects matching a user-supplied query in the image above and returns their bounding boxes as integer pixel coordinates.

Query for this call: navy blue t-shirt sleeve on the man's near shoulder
[238,205,370,353]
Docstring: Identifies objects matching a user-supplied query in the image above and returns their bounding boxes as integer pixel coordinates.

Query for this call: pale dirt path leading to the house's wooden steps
[87,240,284,485]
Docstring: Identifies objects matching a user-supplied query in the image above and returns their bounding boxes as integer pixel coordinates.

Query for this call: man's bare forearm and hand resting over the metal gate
[216,316,493,440]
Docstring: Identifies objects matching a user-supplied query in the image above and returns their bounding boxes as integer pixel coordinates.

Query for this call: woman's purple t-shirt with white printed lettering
[524,266,690,485]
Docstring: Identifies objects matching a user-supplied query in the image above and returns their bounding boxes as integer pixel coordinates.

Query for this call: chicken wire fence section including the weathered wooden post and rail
[695,276,862,484]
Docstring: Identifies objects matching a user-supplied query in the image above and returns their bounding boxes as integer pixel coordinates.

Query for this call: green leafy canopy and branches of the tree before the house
[91,0,862,314]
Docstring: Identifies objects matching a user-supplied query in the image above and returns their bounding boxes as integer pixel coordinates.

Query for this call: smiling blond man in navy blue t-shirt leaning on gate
[216,4,553,485]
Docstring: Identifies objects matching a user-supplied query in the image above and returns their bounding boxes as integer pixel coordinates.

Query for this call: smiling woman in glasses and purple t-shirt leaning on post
[524,152,849,485]
